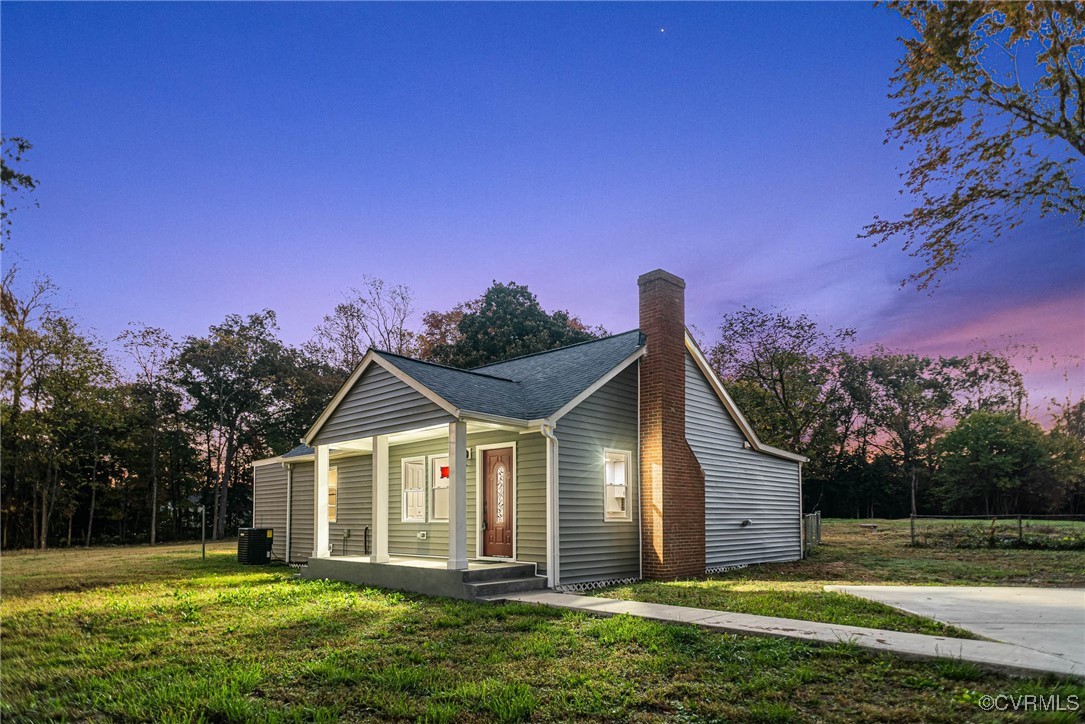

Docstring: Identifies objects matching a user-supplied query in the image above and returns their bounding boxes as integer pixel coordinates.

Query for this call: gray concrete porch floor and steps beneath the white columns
[302,556,547,600]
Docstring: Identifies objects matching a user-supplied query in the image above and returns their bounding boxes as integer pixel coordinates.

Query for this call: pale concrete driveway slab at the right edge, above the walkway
[825,586,1085,664]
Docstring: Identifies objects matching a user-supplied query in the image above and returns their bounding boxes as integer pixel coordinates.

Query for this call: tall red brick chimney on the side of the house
[637,269,704,580]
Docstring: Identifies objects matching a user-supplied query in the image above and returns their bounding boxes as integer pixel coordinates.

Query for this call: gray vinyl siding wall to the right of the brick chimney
[686,354,801,568]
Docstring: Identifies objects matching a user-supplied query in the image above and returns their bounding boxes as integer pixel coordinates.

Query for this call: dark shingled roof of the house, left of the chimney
[378,329,644,420]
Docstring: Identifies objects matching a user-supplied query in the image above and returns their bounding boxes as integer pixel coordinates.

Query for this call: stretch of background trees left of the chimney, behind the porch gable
[0,267,602,548]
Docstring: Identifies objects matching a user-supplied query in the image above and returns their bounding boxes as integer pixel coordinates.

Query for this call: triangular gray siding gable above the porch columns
[312,363,454,445]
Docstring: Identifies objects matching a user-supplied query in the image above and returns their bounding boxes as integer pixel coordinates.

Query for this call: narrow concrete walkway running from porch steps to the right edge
[495,590,1085,677]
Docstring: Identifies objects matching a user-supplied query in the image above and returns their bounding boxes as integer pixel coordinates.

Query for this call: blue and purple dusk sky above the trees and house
[0,2,1085,406]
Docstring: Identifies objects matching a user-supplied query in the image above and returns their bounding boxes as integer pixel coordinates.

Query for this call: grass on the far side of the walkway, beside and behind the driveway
[595,520,1085,638]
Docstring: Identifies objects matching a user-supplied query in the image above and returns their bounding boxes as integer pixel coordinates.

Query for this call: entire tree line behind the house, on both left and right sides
[8,263,1085,548]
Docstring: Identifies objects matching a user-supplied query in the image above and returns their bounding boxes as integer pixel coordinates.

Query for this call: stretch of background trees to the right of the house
[709,307,1085,518]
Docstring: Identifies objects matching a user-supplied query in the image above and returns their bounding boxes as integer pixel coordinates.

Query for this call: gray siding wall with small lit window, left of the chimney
[556,363,640,584]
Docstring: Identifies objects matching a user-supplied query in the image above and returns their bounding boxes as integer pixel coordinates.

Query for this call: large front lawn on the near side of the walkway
[0,543,1085,722]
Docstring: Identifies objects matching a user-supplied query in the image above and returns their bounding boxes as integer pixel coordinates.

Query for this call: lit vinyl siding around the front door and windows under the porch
[388,431,546,572]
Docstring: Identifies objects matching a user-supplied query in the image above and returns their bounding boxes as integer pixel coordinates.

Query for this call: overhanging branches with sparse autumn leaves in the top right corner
[860,0,1085,289]
